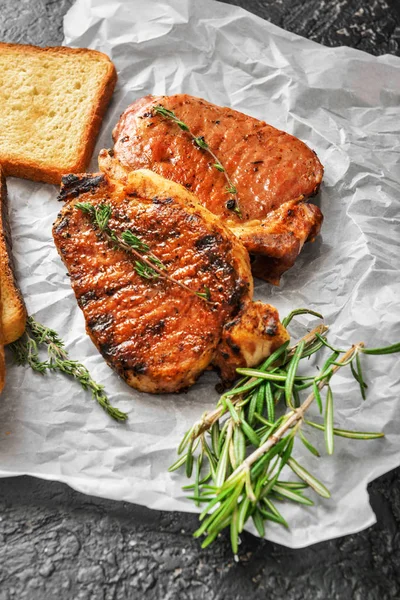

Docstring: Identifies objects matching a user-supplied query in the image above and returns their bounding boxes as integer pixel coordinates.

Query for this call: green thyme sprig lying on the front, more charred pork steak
[75,202,211,303]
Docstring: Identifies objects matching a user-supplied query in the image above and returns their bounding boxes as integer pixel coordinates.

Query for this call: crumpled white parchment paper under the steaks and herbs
[0,0,400,547]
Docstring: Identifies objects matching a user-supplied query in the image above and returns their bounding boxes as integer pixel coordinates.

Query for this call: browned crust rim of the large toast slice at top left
[0,42,117,184]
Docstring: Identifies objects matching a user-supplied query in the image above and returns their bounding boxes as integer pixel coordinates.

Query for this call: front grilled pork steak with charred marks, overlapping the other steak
[53,170,288,393]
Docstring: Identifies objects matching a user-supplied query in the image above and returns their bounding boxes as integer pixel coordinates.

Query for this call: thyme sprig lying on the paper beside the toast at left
[8,317,128,421]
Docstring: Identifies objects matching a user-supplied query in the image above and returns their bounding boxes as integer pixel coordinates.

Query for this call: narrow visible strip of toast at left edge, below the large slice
[0,168,26,344]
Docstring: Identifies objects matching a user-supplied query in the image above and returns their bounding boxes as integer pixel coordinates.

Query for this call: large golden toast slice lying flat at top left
[0,43,117,183]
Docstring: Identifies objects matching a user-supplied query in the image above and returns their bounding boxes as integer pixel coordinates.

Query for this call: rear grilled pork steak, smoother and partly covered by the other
[99,94,323,284]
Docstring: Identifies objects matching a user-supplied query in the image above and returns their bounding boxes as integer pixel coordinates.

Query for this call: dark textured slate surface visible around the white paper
[0,0,400,600]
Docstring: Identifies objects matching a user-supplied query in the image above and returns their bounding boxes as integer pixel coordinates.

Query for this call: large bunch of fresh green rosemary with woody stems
[169,309,400,554]
